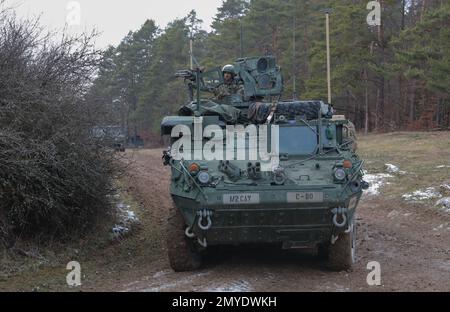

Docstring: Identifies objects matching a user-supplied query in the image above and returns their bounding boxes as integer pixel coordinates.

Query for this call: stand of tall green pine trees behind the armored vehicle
[91,0,450,139]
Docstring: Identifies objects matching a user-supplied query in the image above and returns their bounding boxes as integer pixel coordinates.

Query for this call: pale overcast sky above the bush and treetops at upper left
[6,0,222,48]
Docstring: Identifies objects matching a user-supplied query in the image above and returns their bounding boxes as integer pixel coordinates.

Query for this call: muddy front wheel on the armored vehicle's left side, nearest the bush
[166,206,202,272]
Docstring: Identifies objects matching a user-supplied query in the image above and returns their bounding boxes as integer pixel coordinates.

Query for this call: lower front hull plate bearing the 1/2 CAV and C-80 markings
[173,180,361,248]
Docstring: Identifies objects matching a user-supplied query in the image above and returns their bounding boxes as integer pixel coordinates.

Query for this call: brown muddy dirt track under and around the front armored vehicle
[119,150,450,291]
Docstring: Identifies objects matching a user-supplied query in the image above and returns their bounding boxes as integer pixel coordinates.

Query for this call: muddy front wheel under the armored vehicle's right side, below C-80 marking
[328,222,356,271]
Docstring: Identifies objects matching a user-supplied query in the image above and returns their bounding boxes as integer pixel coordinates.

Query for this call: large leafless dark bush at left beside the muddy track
[0,11,118,242]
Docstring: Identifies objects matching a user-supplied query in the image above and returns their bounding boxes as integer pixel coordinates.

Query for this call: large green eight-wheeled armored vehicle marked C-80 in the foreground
[161,56,368,271]
